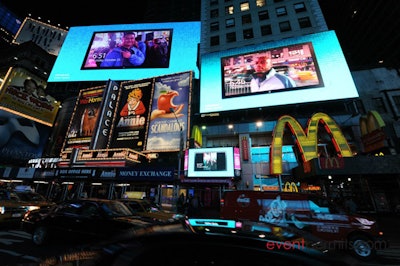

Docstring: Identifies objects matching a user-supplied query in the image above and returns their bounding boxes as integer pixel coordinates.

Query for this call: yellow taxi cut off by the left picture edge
[0,188,55,226]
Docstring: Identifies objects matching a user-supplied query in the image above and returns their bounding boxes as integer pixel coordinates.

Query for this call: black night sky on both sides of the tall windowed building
[0,0,400,68]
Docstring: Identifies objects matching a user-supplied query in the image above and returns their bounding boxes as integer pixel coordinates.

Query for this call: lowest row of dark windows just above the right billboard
[210,17,311,46]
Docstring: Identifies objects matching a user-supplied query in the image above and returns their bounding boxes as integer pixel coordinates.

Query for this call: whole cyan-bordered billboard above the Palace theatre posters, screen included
[48,22,200,82]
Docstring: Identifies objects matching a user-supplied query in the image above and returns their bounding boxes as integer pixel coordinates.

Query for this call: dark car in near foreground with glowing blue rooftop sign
[36,218,356,266]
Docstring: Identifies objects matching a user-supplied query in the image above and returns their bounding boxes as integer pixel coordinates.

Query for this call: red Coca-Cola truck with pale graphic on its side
[220,190,388,260]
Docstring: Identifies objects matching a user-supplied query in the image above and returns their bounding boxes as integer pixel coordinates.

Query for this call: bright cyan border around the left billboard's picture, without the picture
[48,22,200,82]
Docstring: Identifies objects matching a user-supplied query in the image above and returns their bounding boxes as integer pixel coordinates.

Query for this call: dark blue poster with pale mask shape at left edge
[0,110,51,165]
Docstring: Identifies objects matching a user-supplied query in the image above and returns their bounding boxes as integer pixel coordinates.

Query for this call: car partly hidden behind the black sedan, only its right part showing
[119,198,185,223]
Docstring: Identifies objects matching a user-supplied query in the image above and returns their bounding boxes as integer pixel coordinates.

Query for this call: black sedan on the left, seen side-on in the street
[21,198,155,245]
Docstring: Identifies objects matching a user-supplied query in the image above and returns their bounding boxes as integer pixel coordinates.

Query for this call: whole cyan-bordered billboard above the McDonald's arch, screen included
[200,31,358,113]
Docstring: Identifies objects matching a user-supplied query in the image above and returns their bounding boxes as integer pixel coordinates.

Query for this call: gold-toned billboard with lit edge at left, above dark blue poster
[0,67,60,127]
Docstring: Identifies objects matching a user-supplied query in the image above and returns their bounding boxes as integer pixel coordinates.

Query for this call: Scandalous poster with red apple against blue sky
[146,72,192,152]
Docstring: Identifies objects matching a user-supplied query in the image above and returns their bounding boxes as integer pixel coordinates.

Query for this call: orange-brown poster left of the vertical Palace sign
[62,86,105,151]
